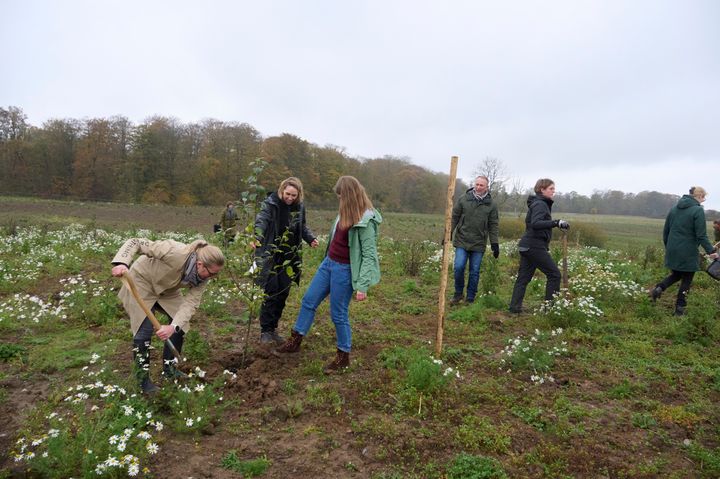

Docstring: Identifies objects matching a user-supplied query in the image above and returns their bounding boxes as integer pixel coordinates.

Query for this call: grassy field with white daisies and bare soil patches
[0,198,720,479]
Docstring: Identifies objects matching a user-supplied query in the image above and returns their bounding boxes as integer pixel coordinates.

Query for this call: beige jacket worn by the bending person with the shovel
[112,238,207,335]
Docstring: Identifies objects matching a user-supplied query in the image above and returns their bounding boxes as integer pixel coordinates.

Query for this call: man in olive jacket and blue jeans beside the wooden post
[451,176,500,304]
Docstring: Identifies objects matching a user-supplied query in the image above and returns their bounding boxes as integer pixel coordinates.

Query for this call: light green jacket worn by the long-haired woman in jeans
[325,209,382,293]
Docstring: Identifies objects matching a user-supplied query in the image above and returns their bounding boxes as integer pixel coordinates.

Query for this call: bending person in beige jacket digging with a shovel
[112,238,225,394]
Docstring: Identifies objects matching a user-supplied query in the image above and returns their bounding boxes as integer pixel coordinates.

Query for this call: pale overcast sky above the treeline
[0,0,720,210]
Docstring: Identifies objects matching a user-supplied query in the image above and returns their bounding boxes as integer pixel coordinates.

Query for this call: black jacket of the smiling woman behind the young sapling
[255,192,315,285]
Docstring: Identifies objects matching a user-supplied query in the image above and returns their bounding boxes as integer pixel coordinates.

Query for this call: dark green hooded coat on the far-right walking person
[663,195,713,272]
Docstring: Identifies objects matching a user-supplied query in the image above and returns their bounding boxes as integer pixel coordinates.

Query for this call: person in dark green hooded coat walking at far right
[650,186,718,316]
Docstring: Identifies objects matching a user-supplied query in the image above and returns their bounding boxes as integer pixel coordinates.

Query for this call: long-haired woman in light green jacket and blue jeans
[276,176,382,374]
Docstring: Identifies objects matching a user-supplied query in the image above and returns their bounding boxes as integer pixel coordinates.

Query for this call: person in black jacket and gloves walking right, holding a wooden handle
[510,178,570,314]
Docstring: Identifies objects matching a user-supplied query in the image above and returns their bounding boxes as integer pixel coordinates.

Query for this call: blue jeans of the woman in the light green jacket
[293,256,353,353]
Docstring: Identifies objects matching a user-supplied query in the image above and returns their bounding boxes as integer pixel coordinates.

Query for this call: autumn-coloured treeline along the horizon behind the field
[0,106,720,219]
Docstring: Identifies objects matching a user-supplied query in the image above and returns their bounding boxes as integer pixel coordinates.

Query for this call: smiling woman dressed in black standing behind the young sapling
[251,177,318,344]
